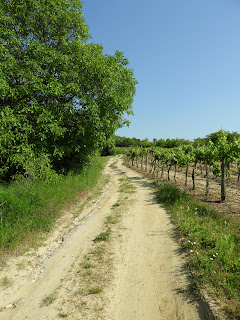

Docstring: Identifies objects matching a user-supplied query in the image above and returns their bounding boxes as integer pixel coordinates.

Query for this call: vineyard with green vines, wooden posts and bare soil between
[125,130,240,219]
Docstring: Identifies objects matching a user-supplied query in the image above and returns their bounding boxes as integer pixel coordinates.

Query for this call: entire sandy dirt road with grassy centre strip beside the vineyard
[0,158,212,320]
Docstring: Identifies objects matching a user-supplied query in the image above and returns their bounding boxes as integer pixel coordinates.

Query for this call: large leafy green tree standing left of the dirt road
[0,0,136,179]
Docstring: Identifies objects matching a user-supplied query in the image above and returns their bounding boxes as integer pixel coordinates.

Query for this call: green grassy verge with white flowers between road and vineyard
[156,183,240,319]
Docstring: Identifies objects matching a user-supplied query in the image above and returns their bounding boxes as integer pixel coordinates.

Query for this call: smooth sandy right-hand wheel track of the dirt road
[103,162,210,320]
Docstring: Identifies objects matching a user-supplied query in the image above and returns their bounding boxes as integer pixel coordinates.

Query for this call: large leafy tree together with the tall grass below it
[0,0,137,251]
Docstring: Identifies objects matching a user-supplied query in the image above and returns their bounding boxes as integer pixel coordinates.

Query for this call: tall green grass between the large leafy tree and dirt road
[0,158,106,250]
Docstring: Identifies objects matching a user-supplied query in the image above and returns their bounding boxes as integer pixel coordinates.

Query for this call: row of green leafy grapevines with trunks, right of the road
[125,130,240,202]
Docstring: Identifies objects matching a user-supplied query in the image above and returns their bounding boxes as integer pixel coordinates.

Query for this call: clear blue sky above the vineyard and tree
[83,0,240,140]
